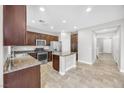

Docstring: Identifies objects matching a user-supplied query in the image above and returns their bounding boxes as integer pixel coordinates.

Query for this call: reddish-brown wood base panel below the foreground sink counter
[4,65,41,88]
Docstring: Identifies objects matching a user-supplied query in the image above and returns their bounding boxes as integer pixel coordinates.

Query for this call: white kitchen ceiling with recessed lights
[27,5,124,32]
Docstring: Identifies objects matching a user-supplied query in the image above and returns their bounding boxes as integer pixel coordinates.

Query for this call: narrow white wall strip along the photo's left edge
[0,5,3,87]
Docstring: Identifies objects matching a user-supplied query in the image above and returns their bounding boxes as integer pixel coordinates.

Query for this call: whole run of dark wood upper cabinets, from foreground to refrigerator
[3,5,58,46]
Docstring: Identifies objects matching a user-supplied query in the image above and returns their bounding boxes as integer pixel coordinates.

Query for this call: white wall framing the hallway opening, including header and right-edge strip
[78,19,124,67]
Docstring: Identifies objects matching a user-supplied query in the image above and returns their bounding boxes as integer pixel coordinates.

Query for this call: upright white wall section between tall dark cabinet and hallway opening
[78,30,93,64]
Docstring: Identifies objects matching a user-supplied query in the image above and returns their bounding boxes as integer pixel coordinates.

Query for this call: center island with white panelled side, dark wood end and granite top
[52,52,76,75]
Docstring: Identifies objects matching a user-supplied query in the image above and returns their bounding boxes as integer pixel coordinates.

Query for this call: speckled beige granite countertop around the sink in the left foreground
[4,55,41,74]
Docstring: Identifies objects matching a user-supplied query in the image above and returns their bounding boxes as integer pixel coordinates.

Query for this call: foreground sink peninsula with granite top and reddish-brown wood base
[4,55,41,88]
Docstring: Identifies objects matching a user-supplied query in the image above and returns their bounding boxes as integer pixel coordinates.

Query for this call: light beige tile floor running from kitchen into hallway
[41,54,124,88]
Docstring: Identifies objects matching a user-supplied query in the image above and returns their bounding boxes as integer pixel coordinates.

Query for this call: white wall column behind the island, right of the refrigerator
[59,32,71,53]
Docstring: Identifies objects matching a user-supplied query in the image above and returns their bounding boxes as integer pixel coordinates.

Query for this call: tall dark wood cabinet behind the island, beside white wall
[71,33,78,60]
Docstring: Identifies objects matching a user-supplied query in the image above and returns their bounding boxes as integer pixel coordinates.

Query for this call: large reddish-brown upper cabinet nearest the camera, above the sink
[3,5,26,45]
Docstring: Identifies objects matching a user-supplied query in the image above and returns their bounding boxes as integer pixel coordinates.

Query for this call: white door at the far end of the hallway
[103,38,112,53]
